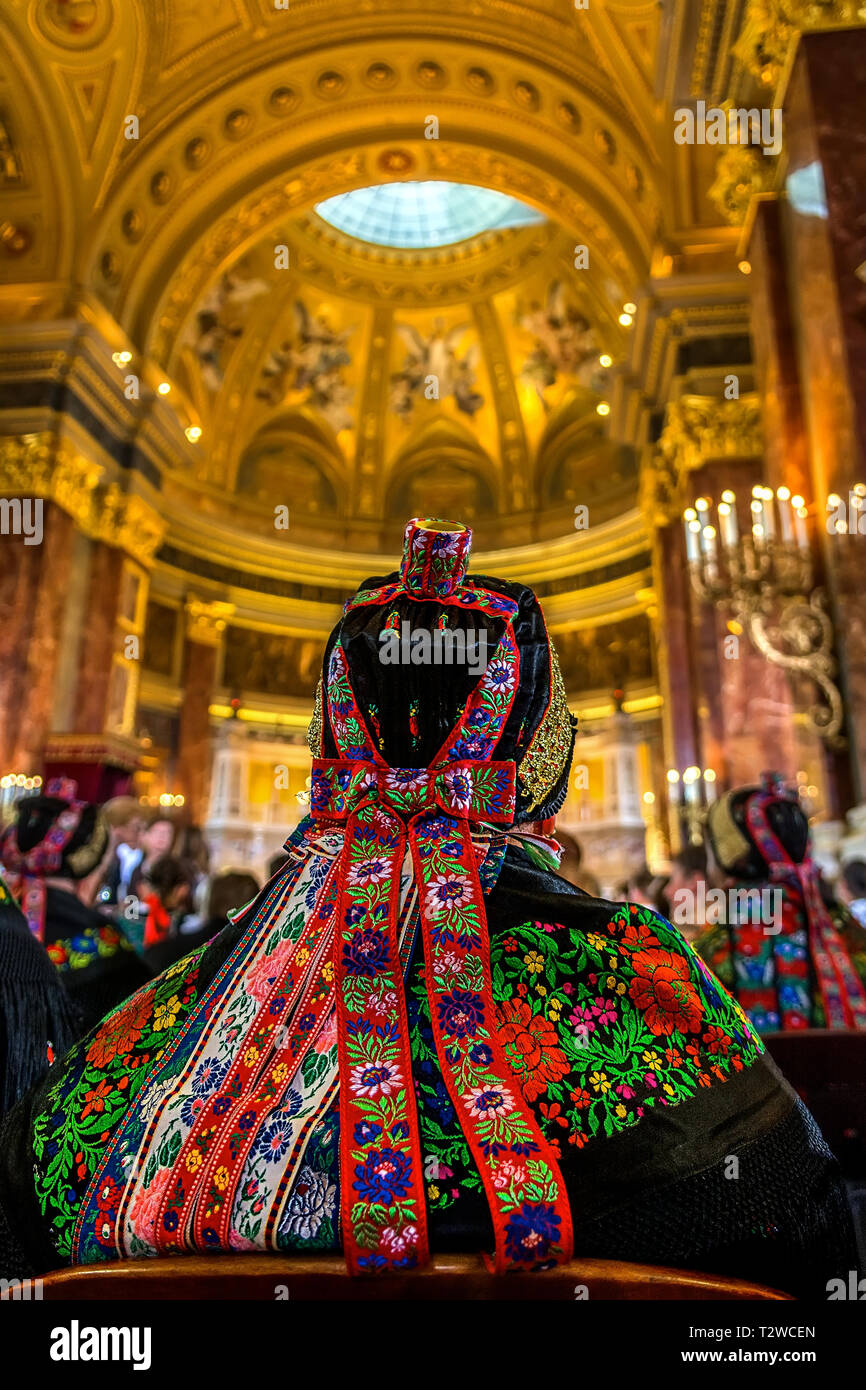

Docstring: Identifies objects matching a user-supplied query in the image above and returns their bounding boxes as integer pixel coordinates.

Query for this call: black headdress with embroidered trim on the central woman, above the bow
[309,520,577,823]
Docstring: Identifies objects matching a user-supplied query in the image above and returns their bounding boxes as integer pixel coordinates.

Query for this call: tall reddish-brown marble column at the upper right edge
[784,29,866,801]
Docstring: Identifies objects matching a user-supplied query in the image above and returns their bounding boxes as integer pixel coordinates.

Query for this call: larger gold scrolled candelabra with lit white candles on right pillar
[684,484,844,746]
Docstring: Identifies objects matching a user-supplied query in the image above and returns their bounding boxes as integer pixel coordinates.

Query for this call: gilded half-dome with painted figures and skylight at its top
[164,191,637,539]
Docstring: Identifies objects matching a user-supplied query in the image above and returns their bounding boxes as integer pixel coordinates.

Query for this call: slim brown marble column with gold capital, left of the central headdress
[177,599,234,824]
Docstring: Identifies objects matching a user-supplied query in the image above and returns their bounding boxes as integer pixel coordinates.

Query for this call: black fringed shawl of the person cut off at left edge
[0,878,83,1115]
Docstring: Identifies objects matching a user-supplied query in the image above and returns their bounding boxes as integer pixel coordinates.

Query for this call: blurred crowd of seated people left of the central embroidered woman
[0,780,273,1113]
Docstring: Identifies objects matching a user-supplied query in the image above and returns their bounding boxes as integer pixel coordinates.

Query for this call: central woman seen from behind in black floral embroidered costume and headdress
[0,521,848,1284]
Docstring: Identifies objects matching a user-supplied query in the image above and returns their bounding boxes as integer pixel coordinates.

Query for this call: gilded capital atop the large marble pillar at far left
[0,434,165,566]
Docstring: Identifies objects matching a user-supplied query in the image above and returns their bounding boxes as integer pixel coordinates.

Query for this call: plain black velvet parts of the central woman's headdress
[322,574,574,823]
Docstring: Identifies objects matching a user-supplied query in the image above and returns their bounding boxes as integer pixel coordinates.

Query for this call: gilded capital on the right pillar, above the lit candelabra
[641,392,763,527]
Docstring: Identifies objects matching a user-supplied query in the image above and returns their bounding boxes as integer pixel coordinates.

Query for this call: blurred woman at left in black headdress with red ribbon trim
[0,778,150,1031]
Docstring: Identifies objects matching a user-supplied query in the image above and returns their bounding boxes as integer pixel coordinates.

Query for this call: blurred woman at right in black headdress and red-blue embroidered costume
[695,773,866,1034]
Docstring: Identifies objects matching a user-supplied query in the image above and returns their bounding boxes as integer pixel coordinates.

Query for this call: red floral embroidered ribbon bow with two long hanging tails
[311,759,573,1273]
